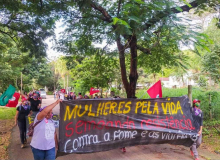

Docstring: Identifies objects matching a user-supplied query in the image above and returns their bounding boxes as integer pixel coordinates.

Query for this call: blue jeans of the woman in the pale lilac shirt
[31,146,56,160]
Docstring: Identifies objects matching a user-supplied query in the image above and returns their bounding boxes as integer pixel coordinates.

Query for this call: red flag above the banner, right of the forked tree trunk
[147,80,162,98]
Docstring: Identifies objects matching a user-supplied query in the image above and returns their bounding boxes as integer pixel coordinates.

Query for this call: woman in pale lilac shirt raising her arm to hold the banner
[30,99,62,160]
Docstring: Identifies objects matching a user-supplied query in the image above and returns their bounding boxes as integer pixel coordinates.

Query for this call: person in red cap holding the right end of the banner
[190,99,203,160]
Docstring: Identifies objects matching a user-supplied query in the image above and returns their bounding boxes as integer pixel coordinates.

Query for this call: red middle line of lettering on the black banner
[65,116,195,137]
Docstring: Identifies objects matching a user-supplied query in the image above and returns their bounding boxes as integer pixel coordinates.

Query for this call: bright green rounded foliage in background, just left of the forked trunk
[68,49,120,93]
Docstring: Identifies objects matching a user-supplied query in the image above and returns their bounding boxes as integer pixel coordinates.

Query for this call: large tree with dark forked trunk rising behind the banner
[55,0,220,98]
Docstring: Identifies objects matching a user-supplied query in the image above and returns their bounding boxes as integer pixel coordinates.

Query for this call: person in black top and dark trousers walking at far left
[15,99,31,148]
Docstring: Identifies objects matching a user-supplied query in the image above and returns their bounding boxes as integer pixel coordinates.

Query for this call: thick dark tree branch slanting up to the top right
[144,0,206,30]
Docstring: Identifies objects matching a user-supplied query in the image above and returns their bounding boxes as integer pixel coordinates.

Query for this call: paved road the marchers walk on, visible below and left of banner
[9,96,220,160]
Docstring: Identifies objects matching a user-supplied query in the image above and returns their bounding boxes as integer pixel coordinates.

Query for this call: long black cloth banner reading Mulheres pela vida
[57,96,198,156]
